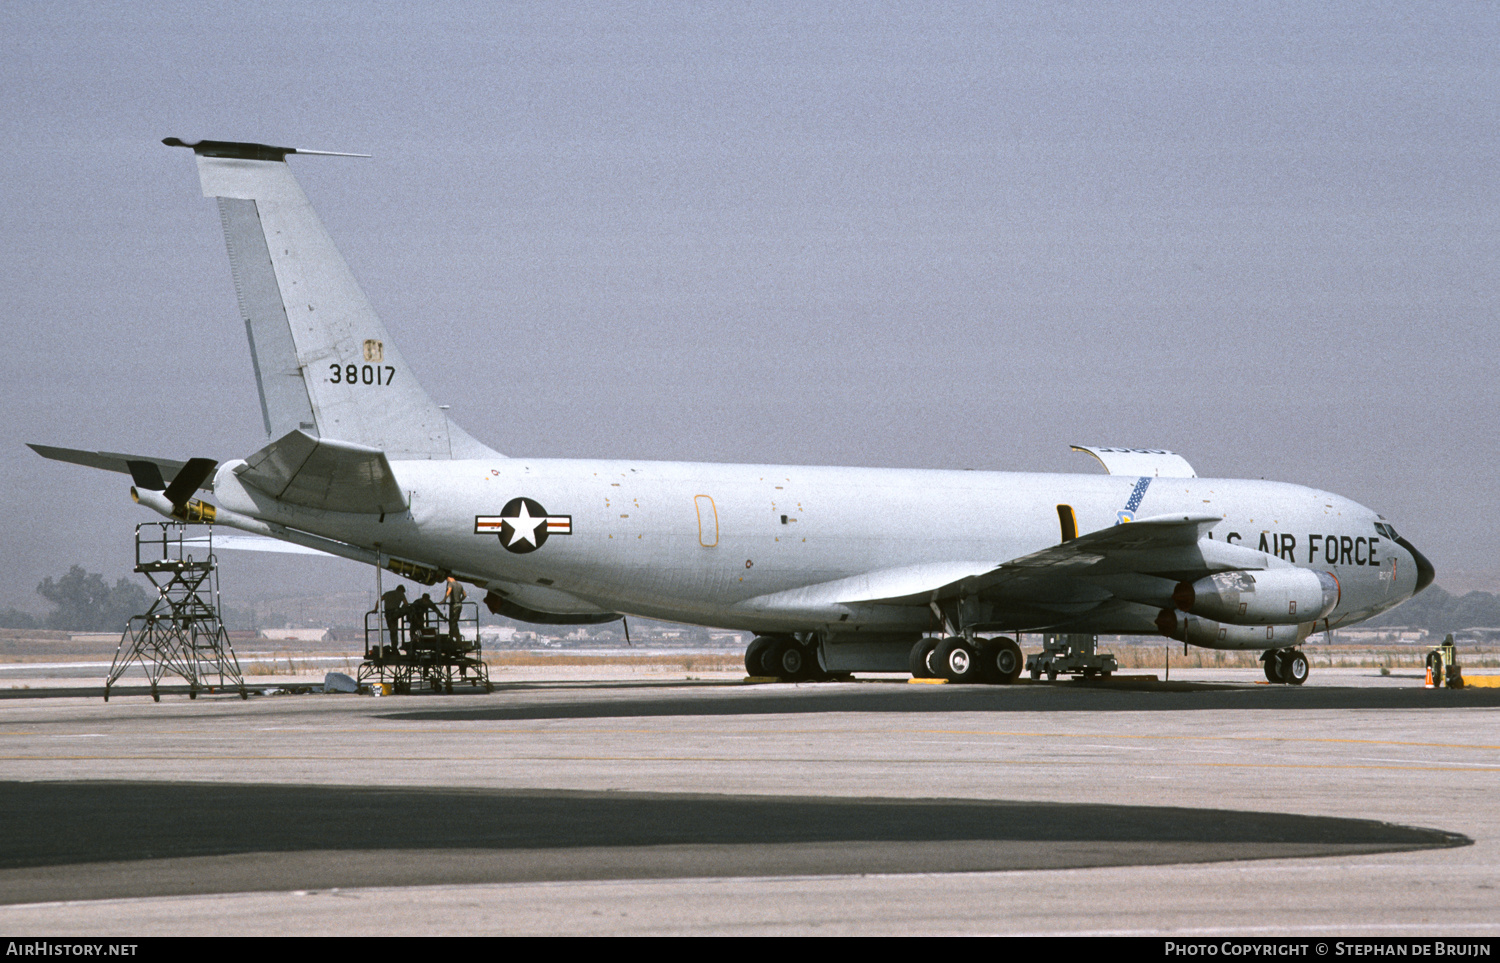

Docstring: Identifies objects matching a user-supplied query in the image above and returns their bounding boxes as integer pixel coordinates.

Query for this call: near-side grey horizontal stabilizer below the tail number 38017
[234,429,407,515]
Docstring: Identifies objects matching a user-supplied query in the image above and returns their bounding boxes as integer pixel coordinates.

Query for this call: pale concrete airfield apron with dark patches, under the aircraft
[0,669,1500,938]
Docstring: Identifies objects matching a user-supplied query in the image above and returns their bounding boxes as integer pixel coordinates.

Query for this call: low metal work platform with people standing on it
[357,600,495,695]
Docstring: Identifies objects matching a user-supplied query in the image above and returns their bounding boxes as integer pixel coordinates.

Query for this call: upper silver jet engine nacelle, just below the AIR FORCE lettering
[1172,569,1340,626]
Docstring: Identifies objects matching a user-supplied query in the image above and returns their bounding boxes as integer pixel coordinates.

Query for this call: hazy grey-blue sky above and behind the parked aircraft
[0,0,1500,608]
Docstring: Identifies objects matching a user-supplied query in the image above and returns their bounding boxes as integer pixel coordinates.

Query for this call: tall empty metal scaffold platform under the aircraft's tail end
[104,522,249,702]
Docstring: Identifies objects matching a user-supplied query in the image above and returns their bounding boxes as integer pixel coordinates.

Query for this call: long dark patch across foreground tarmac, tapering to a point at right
[0,782,1472,903]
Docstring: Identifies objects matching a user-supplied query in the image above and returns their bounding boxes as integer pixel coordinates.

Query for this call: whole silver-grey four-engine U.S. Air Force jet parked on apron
[33,138,1434,683]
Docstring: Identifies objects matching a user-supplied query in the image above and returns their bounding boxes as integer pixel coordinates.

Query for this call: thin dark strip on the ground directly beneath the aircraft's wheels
[383,683,1500,722]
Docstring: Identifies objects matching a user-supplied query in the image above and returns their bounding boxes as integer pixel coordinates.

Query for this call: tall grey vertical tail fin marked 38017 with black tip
[162,138,498,459]
